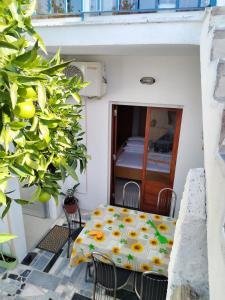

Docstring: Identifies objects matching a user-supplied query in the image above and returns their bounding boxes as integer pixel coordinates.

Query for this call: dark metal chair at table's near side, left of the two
[91,252,131,300]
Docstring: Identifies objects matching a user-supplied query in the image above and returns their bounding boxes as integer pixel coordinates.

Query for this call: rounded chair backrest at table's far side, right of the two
[156,188,177,217]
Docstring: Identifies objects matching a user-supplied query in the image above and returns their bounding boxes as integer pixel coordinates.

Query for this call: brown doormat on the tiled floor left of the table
[37,225,69,253]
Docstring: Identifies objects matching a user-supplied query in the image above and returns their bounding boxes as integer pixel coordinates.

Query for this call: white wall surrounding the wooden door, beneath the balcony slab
[72,55,203,214]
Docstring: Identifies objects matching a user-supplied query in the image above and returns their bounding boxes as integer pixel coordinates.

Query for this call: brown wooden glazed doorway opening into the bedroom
[110,105,182,215]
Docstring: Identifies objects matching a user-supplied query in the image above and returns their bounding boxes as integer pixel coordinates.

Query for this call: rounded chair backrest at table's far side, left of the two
[123,181,141,209]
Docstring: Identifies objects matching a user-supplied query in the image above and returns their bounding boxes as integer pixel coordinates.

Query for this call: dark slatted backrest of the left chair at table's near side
[91,252,117,300]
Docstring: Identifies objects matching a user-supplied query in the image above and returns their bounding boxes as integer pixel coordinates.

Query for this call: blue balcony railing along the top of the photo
[36,0,216,18]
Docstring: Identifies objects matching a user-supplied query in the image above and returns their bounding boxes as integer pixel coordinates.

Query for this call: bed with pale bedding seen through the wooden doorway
[115,137,171,180]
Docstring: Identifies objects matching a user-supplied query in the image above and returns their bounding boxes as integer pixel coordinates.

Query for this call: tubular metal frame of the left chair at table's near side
[91,251,129,300]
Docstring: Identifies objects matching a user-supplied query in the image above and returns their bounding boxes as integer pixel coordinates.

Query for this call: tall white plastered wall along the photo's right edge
[200,7,225,300]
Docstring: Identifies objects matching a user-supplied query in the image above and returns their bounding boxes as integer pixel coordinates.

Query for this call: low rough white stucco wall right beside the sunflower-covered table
[167,169,207,300]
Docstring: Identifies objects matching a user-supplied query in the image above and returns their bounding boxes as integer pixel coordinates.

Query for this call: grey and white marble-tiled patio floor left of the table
[0,212,93,300]
